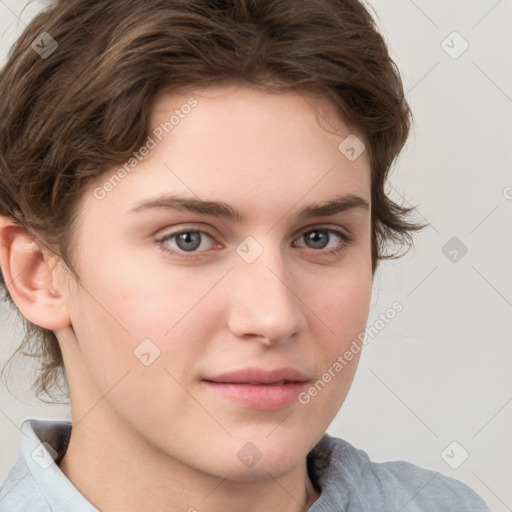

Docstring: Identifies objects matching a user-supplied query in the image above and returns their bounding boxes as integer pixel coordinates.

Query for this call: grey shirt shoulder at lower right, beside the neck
[313,436,490,512]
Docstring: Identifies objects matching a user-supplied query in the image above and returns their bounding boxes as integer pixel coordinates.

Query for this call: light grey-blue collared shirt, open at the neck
[0,419,490,512]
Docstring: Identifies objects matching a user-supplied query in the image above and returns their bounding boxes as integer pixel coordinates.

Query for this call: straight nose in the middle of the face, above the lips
[228,245,306,346]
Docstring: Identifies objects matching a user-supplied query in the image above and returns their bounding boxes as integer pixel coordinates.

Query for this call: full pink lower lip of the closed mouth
[202,381,307,411]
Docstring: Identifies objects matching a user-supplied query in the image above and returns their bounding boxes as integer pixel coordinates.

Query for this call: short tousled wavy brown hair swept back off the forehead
[0,0,425,397]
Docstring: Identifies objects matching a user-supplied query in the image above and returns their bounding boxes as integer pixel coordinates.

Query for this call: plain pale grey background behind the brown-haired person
[0,0,512,512]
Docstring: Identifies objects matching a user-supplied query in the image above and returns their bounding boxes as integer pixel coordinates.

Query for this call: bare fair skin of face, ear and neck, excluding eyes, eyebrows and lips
[0,85,372,512]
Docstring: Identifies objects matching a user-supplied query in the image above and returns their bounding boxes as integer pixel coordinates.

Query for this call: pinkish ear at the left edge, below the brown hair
[0,217,71,331]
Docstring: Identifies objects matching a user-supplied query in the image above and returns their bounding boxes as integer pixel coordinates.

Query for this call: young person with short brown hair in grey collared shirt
[0,0,488,512]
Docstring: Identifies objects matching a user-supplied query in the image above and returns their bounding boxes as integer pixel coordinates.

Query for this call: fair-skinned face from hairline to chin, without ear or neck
[59,86,372,480]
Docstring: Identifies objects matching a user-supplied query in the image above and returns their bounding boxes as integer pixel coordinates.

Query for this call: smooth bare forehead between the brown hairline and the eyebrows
[82,85,370,226]
